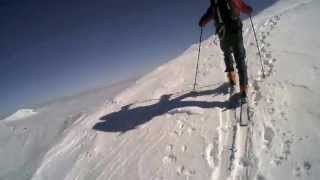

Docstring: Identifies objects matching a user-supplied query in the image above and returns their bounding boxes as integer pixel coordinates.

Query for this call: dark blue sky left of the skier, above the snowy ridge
[0,0,274,114]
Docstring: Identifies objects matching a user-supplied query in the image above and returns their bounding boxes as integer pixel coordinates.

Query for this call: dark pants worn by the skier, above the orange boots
[220,27,248,85]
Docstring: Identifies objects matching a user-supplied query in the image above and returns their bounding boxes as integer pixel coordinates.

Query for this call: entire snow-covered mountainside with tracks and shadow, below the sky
[0,0,320,180]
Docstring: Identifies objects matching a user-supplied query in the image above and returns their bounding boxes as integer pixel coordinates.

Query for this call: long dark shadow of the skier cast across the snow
[93,83,238,133]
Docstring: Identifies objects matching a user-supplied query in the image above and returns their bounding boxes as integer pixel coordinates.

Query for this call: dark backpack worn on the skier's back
[211,0,242,36]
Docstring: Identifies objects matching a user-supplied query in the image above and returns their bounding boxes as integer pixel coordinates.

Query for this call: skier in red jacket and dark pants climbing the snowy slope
[199,0,252,98]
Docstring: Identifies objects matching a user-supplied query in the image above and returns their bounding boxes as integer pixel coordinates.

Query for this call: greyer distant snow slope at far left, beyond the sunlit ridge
[0,82,132,180]
